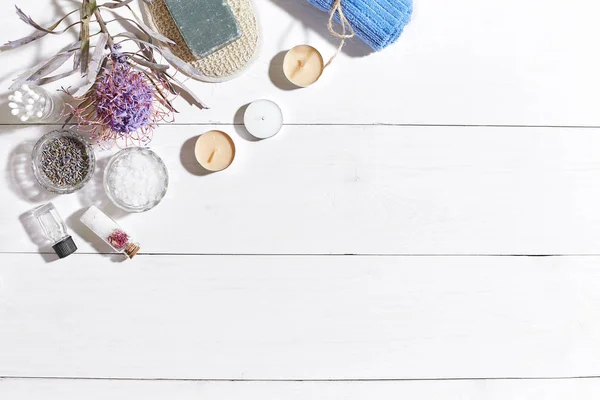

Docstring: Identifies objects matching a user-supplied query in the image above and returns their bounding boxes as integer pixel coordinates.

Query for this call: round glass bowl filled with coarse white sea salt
[104,147,169,212]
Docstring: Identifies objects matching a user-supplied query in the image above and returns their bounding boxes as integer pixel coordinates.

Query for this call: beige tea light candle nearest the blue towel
[283,44,325,87]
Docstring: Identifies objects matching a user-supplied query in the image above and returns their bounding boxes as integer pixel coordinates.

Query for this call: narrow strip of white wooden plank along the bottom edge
[0,379,600,400]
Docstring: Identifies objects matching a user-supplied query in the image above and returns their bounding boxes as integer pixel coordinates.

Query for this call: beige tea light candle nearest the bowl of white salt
[195,130,235,172]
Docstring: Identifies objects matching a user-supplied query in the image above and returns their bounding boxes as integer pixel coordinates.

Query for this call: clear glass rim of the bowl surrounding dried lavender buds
[31,129,96,194]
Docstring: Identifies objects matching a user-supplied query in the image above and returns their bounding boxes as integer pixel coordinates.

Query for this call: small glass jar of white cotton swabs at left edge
[8,84,65,123]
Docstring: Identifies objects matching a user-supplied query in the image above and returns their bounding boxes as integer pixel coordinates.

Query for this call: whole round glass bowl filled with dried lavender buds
[31,130,96,194]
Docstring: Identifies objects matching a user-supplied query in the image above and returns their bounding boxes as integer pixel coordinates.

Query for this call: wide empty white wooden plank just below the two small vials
[0,255,600,379]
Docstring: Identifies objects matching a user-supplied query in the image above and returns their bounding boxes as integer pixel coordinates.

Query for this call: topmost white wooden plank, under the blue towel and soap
[0,0,600,125]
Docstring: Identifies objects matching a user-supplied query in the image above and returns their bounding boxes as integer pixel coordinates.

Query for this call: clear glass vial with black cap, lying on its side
[33,203,77,258]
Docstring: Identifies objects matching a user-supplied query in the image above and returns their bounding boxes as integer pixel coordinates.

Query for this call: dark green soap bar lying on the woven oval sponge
[165,0,242,58]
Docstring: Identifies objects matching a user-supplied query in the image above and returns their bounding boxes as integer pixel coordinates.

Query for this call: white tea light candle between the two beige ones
[244,100,283,139]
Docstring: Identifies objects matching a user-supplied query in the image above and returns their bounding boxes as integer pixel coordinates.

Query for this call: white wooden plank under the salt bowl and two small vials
[0,126,600,254]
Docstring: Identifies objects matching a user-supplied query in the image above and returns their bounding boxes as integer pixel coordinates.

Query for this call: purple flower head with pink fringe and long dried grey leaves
[0,0,206,143]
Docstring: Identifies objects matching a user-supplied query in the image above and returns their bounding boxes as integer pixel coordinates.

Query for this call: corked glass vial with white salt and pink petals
[81,206,140,258]
